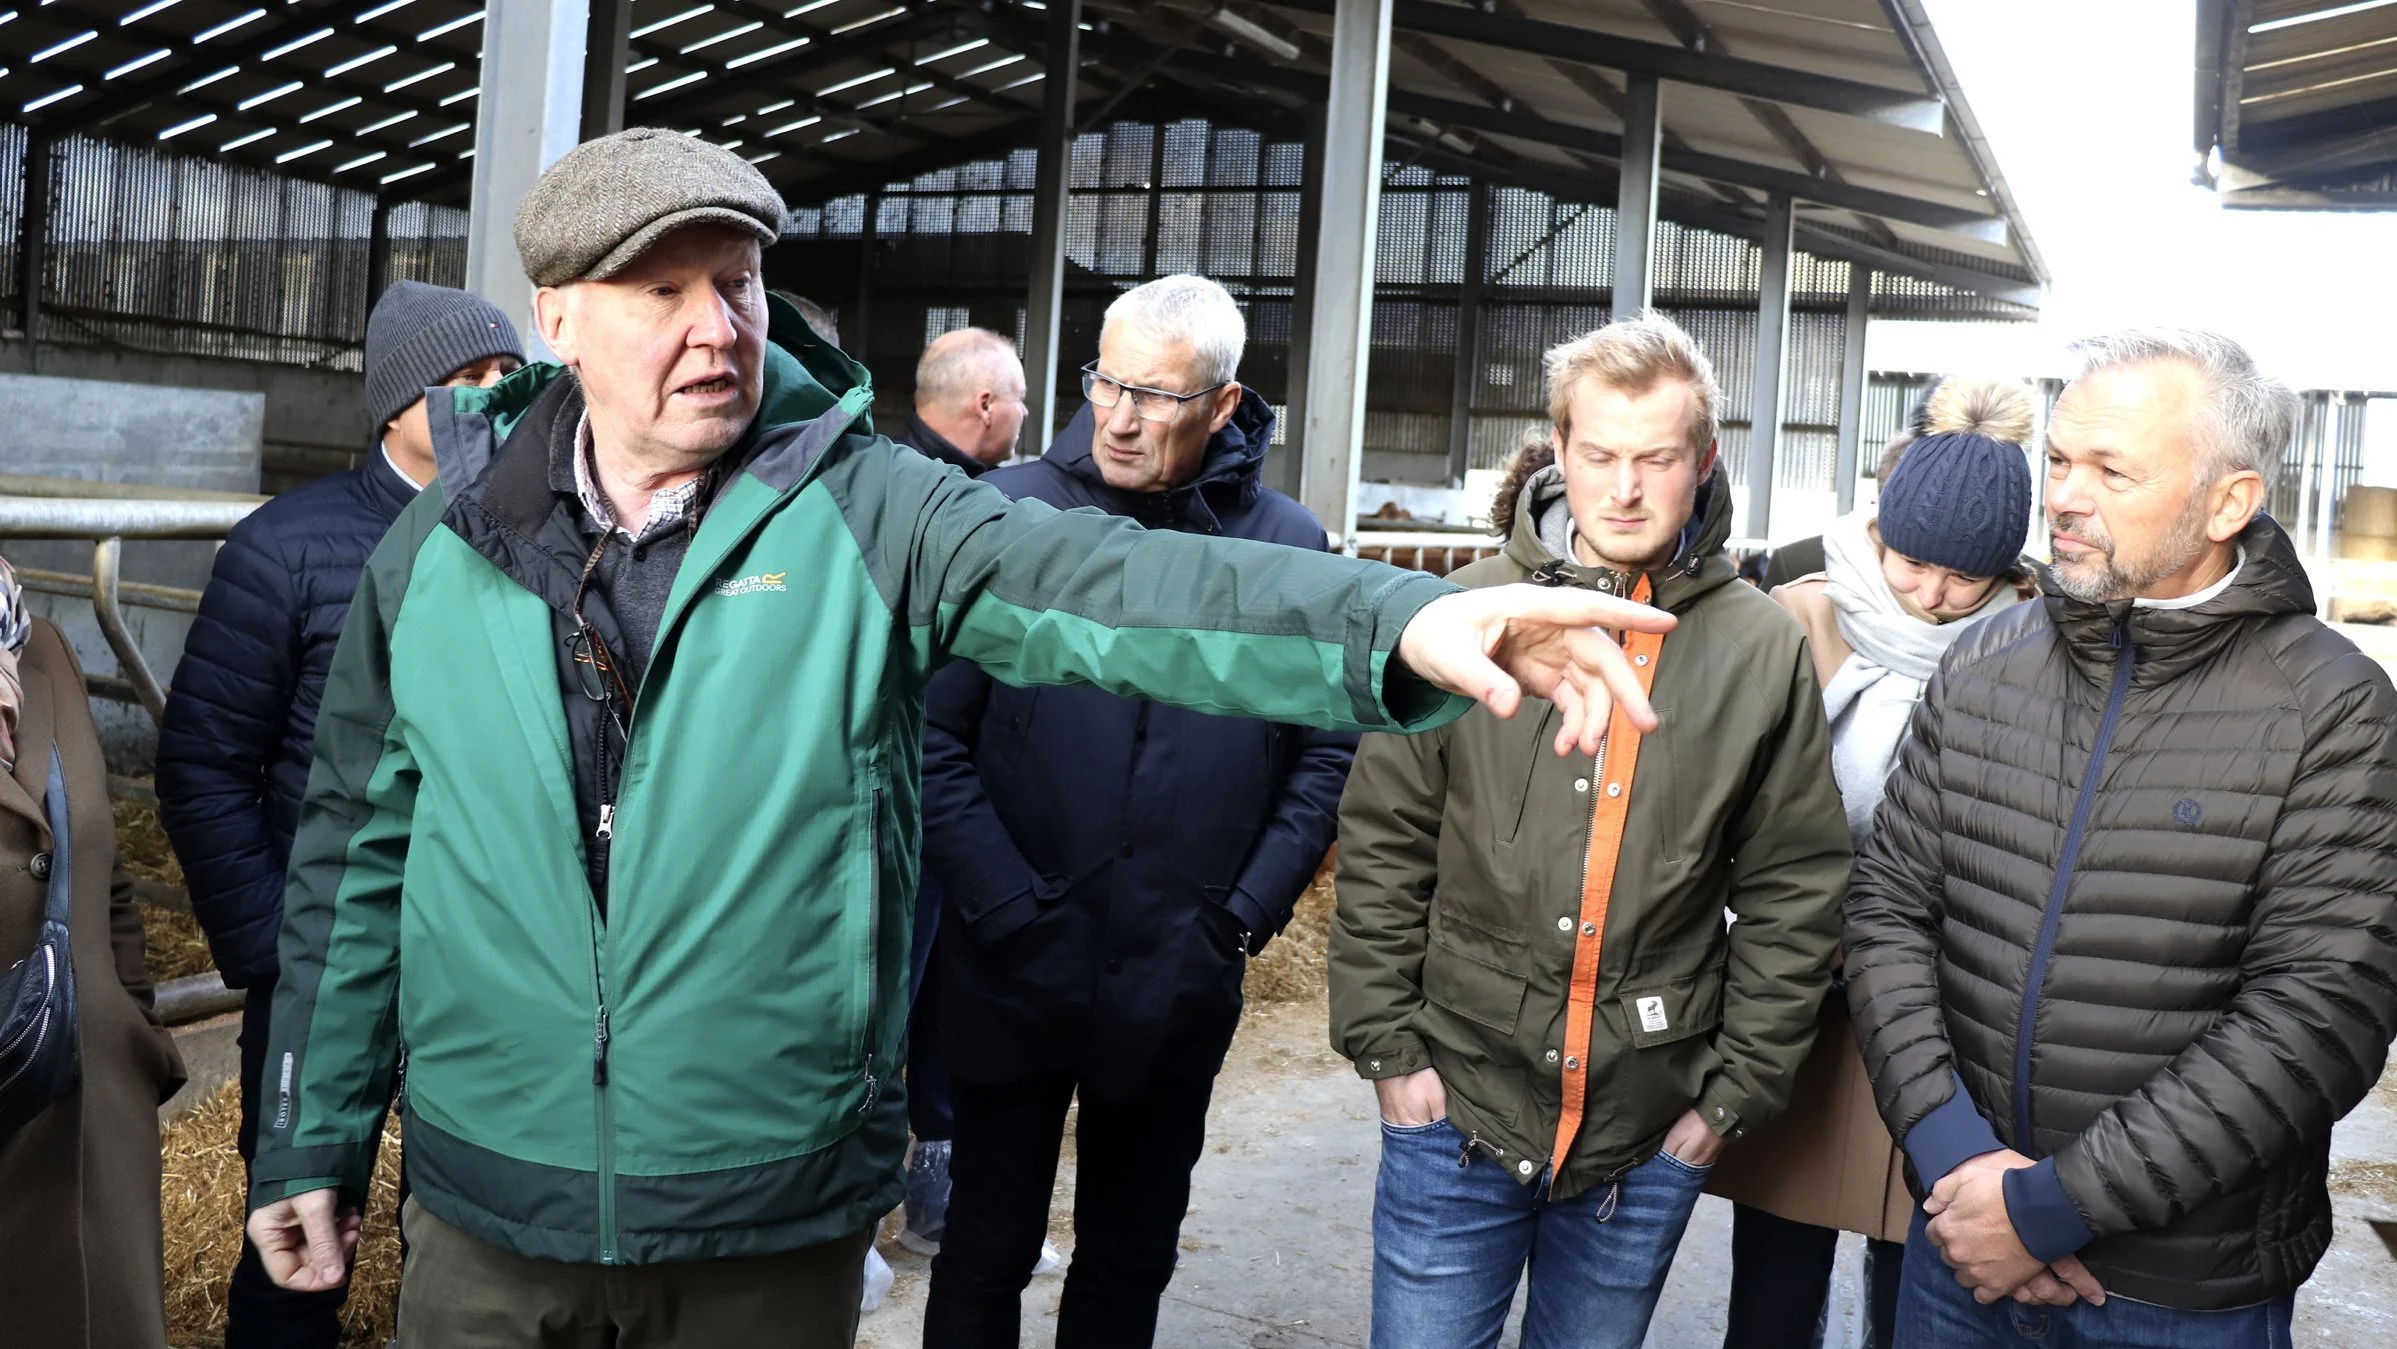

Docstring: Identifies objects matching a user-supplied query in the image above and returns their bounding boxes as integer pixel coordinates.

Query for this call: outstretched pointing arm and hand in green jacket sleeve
[858,446,1673,752]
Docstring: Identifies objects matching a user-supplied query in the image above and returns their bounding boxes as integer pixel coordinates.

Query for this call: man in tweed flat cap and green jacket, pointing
[249,127,1671,1349]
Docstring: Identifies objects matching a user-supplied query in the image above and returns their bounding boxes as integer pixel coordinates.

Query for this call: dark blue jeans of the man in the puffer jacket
[1896,1212,2296,1349]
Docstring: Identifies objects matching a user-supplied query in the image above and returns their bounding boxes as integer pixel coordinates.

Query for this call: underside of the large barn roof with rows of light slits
[0,0,2045,300]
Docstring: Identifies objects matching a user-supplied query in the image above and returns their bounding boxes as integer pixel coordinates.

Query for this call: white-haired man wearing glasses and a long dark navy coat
[923,276,1357,1349]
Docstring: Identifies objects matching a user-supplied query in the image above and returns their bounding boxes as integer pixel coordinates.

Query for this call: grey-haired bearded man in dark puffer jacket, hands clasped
[1846,331,2397,1349]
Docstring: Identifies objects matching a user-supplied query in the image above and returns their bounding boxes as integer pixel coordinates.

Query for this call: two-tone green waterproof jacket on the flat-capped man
[252,302,1462,1263]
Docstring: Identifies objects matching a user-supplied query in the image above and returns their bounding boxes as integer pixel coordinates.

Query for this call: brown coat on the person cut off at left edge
[0,621,182,1349]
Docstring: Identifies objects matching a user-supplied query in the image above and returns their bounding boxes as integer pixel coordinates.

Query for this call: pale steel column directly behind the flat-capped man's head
[465,0,590,357]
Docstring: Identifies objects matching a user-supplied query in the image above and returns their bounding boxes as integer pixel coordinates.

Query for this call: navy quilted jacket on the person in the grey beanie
[158,453,415,987]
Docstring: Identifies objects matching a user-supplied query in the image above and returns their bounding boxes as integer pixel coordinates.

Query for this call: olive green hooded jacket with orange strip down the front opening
[1330,467,1850,1198]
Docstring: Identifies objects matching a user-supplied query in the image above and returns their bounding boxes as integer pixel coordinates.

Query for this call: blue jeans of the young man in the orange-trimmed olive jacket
[1373,1121,1707,1349]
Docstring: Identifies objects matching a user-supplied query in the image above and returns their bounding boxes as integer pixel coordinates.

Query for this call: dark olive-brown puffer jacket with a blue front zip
[1848,518,2397,1308]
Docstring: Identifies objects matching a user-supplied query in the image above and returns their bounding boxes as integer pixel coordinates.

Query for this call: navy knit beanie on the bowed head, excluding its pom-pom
[1877,431,2030,575]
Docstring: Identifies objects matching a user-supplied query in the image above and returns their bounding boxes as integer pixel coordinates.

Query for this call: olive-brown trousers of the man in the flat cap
[400,1200,873,1349]
